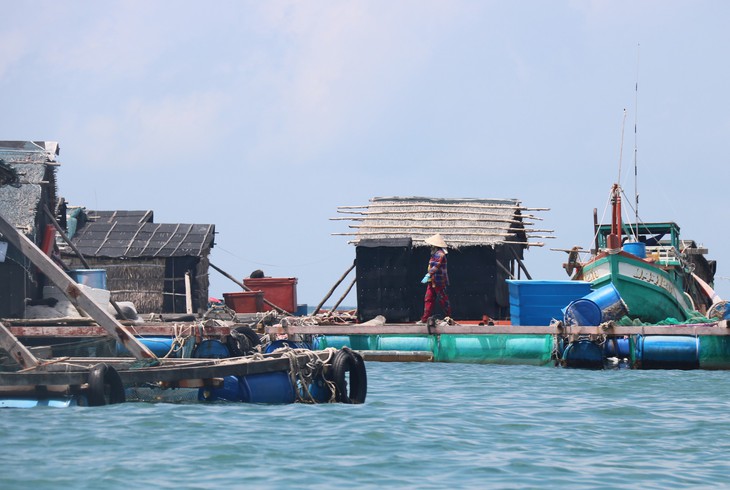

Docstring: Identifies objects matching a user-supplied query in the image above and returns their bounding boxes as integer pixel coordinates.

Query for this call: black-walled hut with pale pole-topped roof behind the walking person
[335,197,552,322]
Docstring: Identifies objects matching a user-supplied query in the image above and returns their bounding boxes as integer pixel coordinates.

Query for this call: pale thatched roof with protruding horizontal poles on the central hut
[332,197,553,248]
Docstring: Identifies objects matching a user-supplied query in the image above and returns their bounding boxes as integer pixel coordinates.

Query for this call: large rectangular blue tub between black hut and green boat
[507,279,591,325]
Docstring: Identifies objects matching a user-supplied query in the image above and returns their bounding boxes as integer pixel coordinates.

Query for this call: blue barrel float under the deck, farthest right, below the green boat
[636,335,700,369]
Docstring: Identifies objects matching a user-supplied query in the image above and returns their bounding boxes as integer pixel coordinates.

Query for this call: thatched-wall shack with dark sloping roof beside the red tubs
[61,208,215,313]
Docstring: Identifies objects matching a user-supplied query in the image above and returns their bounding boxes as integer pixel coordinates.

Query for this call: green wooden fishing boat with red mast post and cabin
[568,184,714,323]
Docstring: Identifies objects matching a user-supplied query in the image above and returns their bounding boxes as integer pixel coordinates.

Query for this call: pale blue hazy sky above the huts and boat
[0,0,730,305]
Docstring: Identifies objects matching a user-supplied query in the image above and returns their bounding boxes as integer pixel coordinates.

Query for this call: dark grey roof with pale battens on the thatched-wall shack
[72,211,215,258]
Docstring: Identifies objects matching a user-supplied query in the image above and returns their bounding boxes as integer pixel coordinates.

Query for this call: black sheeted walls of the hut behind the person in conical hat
[356,246,509,322]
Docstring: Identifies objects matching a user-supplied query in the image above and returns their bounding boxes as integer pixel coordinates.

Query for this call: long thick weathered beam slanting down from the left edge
[0,215,157,359]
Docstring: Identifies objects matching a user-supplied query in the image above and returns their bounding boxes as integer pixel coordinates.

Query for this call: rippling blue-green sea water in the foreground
[0,362,730,489]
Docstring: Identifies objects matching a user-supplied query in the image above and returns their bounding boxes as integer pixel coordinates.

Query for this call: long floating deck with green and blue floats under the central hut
[266,320,730,369]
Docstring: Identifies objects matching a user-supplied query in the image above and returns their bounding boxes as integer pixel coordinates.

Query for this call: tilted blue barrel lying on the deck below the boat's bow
[563,284,629,326]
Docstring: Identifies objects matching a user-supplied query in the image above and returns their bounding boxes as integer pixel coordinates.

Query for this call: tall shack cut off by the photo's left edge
[0,141,60,318]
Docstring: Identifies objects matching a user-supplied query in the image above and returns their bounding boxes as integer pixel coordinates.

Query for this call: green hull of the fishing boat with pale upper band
[576,252,693,323]
